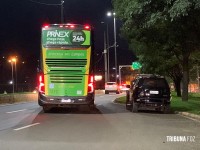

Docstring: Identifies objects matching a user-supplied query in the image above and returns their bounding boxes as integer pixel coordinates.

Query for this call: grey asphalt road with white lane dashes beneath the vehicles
[0,94,200,150]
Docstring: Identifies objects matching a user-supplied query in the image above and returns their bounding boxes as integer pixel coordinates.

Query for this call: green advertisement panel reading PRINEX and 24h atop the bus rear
[42,29,90,47]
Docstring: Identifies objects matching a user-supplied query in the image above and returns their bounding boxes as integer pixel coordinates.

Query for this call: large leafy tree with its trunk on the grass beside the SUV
[113,0,200,101]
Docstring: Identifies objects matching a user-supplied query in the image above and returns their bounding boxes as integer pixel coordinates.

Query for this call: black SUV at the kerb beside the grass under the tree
[126,74,171,113]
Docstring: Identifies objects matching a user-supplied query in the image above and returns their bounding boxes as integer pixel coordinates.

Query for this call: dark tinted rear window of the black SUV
[140,78,168,88]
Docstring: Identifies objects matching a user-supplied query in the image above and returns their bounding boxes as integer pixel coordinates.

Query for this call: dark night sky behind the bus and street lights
[0,0,134,92]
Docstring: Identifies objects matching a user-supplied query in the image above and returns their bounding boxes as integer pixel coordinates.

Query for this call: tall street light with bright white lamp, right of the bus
[107,12,117,82]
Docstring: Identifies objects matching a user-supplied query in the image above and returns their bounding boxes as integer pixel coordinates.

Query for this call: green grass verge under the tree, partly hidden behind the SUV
[115,92,200,115]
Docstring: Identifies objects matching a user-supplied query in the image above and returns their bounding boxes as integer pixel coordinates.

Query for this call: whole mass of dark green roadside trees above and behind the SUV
[113,0,200,101]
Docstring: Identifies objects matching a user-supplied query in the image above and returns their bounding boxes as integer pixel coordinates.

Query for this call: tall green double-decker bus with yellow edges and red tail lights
[38,24,94,112]
